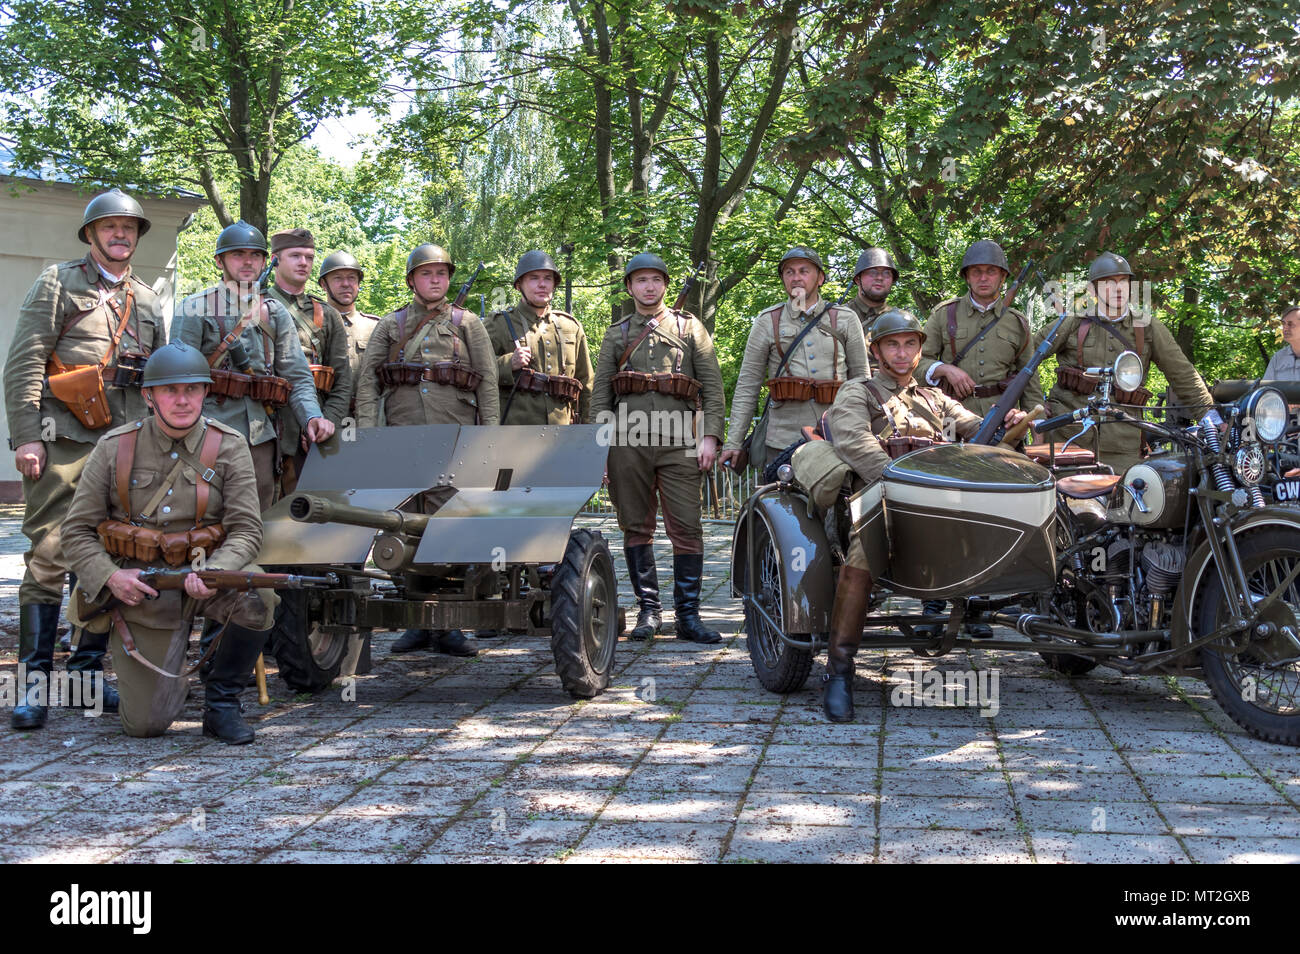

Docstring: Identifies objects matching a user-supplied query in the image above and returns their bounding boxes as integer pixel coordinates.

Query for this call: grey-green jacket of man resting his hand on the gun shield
[172,283,324,447]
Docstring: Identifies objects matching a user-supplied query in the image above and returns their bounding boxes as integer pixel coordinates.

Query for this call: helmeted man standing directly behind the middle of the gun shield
[356,244,498,656]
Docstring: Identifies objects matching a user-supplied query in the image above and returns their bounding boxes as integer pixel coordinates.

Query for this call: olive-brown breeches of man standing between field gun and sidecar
[608,446,705,554]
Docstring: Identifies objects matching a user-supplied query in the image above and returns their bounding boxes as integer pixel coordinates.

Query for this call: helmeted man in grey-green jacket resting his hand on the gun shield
[172,221,334,511]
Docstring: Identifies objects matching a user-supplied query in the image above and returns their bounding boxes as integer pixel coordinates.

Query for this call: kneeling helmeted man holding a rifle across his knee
[64,342,277,745]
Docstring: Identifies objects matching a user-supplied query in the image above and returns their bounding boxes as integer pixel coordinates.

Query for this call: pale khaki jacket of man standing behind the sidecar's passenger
[724,302,867,460]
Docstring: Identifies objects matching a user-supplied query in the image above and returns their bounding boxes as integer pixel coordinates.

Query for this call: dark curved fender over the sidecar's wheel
[731,491,835,634]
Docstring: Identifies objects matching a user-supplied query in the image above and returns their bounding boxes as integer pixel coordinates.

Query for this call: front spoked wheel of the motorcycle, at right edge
[1195,528,1300,746]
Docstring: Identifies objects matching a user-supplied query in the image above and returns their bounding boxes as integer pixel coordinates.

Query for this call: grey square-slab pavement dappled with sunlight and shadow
[0,511,1300,863]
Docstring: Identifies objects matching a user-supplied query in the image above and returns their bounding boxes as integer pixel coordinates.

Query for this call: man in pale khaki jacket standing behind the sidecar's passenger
[722,248,867,471]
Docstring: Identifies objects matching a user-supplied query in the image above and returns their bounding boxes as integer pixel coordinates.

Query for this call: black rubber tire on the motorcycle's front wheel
[1191,526,1300,746]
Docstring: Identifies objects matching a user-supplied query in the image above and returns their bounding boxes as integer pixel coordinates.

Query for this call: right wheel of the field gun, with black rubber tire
[551,530,619,699]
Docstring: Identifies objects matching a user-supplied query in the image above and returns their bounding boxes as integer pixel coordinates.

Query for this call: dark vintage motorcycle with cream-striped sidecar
[732,352,1300,745]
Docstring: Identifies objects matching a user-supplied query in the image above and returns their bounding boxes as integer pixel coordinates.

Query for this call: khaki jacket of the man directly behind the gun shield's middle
[356,299,501,428]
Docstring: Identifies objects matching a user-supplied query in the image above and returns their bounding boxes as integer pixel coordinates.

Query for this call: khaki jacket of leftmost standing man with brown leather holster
[4,253,166,451]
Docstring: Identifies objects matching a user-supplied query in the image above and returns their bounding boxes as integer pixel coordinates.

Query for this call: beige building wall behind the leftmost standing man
[0,177,203,502]
